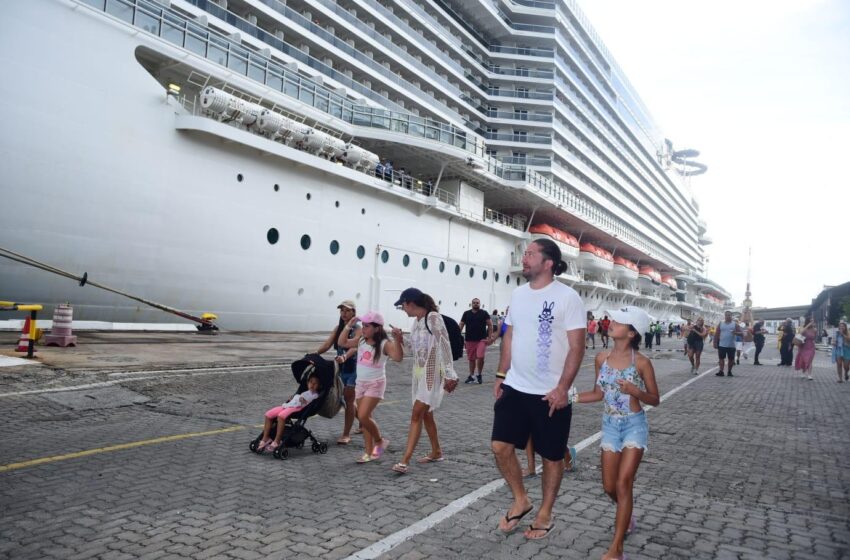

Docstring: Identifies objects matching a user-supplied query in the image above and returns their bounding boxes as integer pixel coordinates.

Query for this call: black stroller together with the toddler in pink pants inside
[249,354,342,459]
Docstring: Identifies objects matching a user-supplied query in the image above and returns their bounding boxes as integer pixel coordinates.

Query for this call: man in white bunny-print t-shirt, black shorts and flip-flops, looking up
[491,239,586,540]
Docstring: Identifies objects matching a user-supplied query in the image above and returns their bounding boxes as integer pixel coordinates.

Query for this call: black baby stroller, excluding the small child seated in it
[248,354,344,459]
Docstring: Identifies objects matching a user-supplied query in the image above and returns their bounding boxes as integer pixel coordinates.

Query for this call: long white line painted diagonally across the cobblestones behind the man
[345,366,717,560]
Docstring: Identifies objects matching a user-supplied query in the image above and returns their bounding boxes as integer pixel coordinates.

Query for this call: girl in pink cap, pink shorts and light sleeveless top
[338,311,404,463]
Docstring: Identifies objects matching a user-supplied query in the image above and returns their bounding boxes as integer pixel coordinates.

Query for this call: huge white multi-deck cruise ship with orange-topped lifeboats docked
[0,0,731,331]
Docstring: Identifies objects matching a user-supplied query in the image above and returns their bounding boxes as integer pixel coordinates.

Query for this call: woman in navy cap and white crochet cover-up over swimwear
[392,288,457,474]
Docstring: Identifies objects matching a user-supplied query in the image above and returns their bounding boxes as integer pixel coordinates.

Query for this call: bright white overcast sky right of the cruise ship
[579,0,850,307]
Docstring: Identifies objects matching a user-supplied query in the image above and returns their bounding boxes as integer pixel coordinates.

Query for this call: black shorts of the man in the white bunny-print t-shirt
[490,383,573,461]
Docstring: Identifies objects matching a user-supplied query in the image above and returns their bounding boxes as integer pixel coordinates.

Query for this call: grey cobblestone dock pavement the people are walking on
[0,334,850,559]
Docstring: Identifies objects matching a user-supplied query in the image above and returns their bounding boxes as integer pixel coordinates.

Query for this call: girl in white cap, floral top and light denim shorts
[574,307,660,560]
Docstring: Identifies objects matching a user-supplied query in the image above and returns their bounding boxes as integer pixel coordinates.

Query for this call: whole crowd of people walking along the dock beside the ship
[252,240,850,560]
